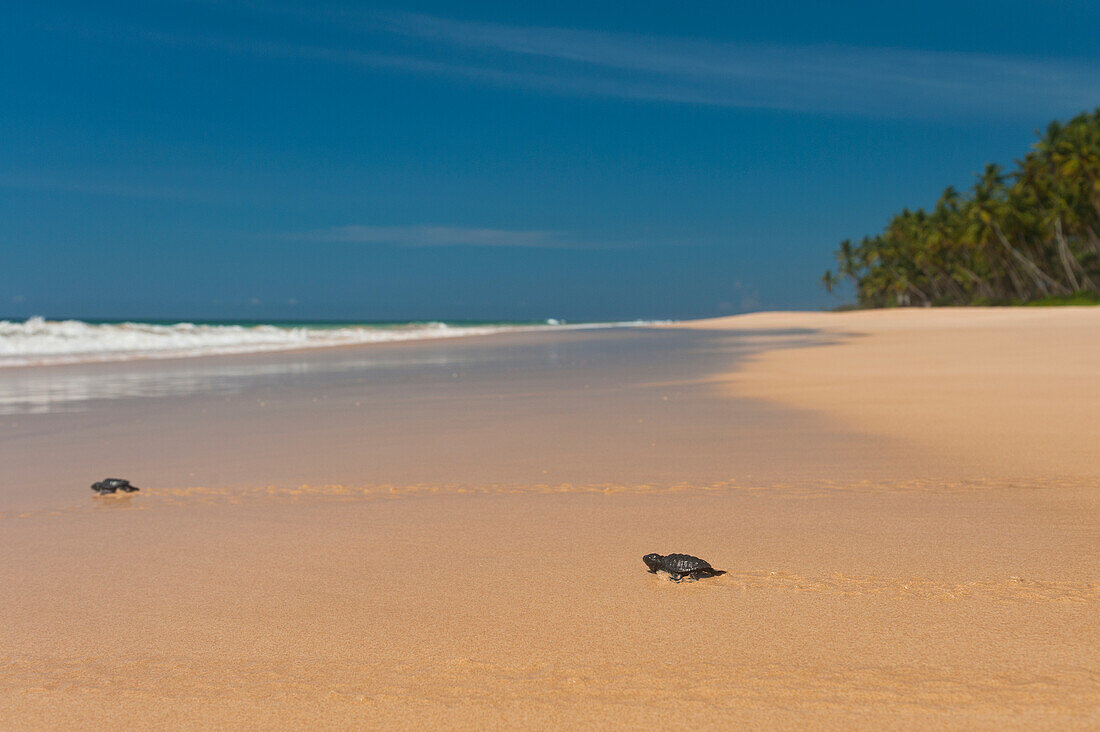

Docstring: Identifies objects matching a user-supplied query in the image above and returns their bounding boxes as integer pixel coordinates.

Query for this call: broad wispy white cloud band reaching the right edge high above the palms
[367,14,1100,116]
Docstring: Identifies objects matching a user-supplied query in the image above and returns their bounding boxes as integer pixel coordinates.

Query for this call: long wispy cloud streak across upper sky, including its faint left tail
[105,7,1100,117]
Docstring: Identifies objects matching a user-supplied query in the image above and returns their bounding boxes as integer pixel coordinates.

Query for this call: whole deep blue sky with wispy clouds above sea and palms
[0,0,1100,320]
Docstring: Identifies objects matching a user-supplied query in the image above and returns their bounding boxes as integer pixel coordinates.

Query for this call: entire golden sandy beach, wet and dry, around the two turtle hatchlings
[0,308,1100,729]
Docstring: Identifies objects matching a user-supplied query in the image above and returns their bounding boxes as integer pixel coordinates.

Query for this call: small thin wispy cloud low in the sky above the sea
[285,225,592,249]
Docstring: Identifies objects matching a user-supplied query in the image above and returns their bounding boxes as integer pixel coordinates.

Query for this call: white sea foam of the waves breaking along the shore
[0,317,651,368]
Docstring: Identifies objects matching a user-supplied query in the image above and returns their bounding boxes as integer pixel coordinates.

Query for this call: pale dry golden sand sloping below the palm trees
[686,307,1100,480]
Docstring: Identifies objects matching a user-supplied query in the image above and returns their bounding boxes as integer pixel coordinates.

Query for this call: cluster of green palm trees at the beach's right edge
[822,109,1100,307]
